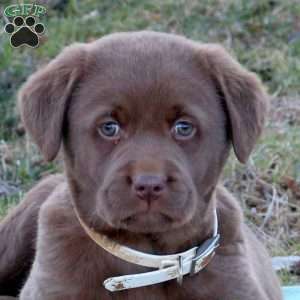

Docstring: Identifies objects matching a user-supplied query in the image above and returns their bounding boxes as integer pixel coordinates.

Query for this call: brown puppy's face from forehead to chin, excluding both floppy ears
[66,49,228,232]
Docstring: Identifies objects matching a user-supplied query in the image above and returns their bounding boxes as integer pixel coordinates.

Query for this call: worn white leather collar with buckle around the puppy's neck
[75,209,220,292]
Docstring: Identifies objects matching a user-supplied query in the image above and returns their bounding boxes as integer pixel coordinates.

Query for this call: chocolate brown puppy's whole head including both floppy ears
[19,32,267,233]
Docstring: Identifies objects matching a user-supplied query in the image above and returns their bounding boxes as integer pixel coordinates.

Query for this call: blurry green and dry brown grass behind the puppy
[0,0,300,282]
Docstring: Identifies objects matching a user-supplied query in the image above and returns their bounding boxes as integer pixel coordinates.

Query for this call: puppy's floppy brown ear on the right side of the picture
[200,44,269,163]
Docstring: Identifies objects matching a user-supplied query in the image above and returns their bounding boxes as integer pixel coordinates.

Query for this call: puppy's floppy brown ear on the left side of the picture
[18,44,85,161]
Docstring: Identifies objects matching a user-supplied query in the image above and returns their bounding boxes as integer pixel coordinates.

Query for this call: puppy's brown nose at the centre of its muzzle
[133,175,166,201]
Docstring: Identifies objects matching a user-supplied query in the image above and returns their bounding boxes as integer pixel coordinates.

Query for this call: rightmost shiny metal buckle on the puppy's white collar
[190,234,220,276]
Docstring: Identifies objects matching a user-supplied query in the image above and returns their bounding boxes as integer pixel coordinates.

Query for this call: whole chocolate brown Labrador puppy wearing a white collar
[0,32,282,300]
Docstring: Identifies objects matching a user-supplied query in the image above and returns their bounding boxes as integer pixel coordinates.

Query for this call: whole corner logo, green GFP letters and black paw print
[4,4,46,48]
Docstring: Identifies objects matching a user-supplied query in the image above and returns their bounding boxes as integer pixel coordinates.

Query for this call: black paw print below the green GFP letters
[4,16,45,48]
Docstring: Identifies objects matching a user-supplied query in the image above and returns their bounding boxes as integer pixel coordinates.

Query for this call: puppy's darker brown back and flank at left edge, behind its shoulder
[0,175,64,299]
